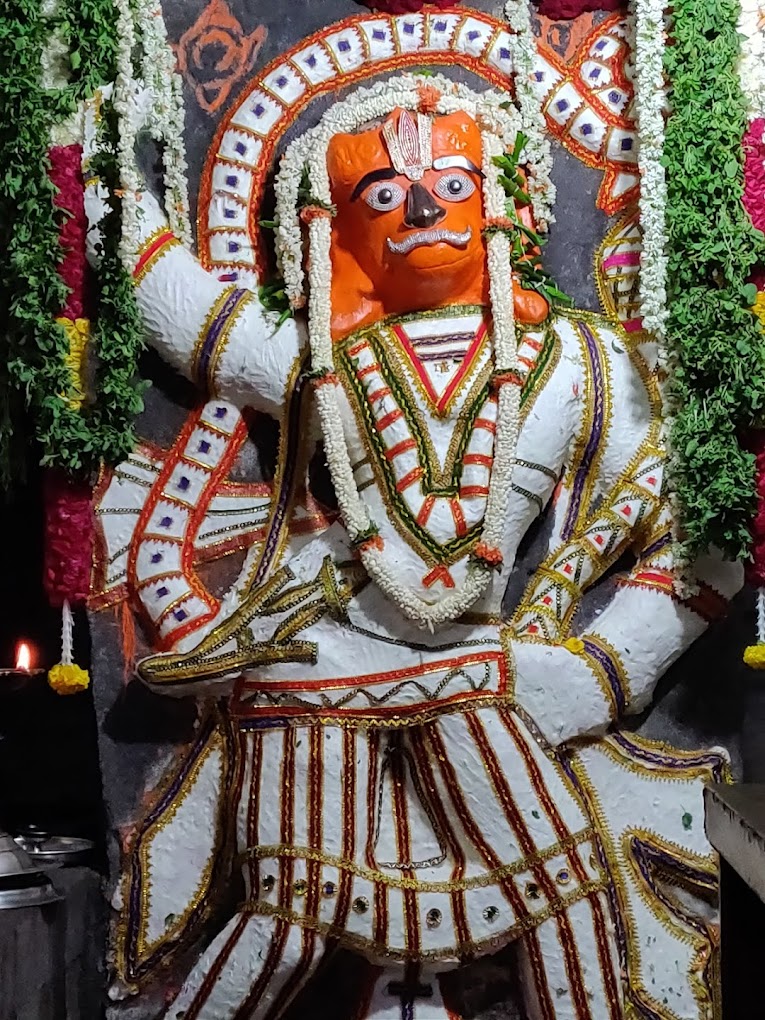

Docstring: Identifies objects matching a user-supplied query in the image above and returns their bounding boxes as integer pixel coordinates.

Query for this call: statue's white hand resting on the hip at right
[511,639,611,747]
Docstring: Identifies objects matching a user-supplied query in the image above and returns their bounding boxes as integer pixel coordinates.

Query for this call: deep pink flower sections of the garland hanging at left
[43,145,93,608]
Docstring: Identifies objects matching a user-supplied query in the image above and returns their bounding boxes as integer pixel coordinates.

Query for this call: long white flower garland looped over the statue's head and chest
[276,74,521,628]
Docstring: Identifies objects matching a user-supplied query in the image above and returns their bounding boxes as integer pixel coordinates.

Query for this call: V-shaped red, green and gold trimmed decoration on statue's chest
[336,314,558,587]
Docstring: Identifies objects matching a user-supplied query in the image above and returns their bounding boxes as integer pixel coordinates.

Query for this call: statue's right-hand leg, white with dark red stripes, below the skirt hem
[518,893,623,1020]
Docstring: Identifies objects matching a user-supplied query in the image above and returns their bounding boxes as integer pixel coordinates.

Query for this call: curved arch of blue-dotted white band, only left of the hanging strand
[198,10,534,287]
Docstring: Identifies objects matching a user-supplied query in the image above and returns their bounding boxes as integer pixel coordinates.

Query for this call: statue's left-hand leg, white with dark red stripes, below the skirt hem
[165,914,324,1020]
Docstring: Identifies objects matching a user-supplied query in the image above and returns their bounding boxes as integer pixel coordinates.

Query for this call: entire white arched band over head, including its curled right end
[197,9,640,287]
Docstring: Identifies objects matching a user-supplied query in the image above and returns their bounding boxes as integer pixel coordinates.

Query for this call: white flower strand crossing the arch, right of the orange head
[505,0,555,232]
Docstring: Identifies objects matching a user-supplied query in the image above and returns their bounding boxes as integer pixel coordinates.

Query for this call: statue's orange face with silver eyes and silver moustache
[327,110,487,334]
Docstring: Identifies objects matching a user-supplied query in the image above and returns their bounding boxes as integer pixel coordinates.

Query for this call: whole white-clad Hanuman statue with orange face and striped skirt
[90,67,741,1020]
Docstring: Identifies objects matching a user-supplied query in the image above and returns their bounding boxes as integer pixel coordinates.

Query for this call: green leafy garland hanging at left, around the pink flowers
[0,0,143,489]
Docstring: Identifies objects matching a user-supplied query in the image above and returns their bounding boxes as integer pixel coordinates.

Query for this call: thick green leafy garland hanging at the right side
[664,0,765,558]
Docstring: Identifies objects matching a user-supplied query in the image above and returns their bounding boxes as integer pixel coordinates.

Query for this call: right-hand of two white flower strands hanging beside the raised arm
[136,0,192,246]
